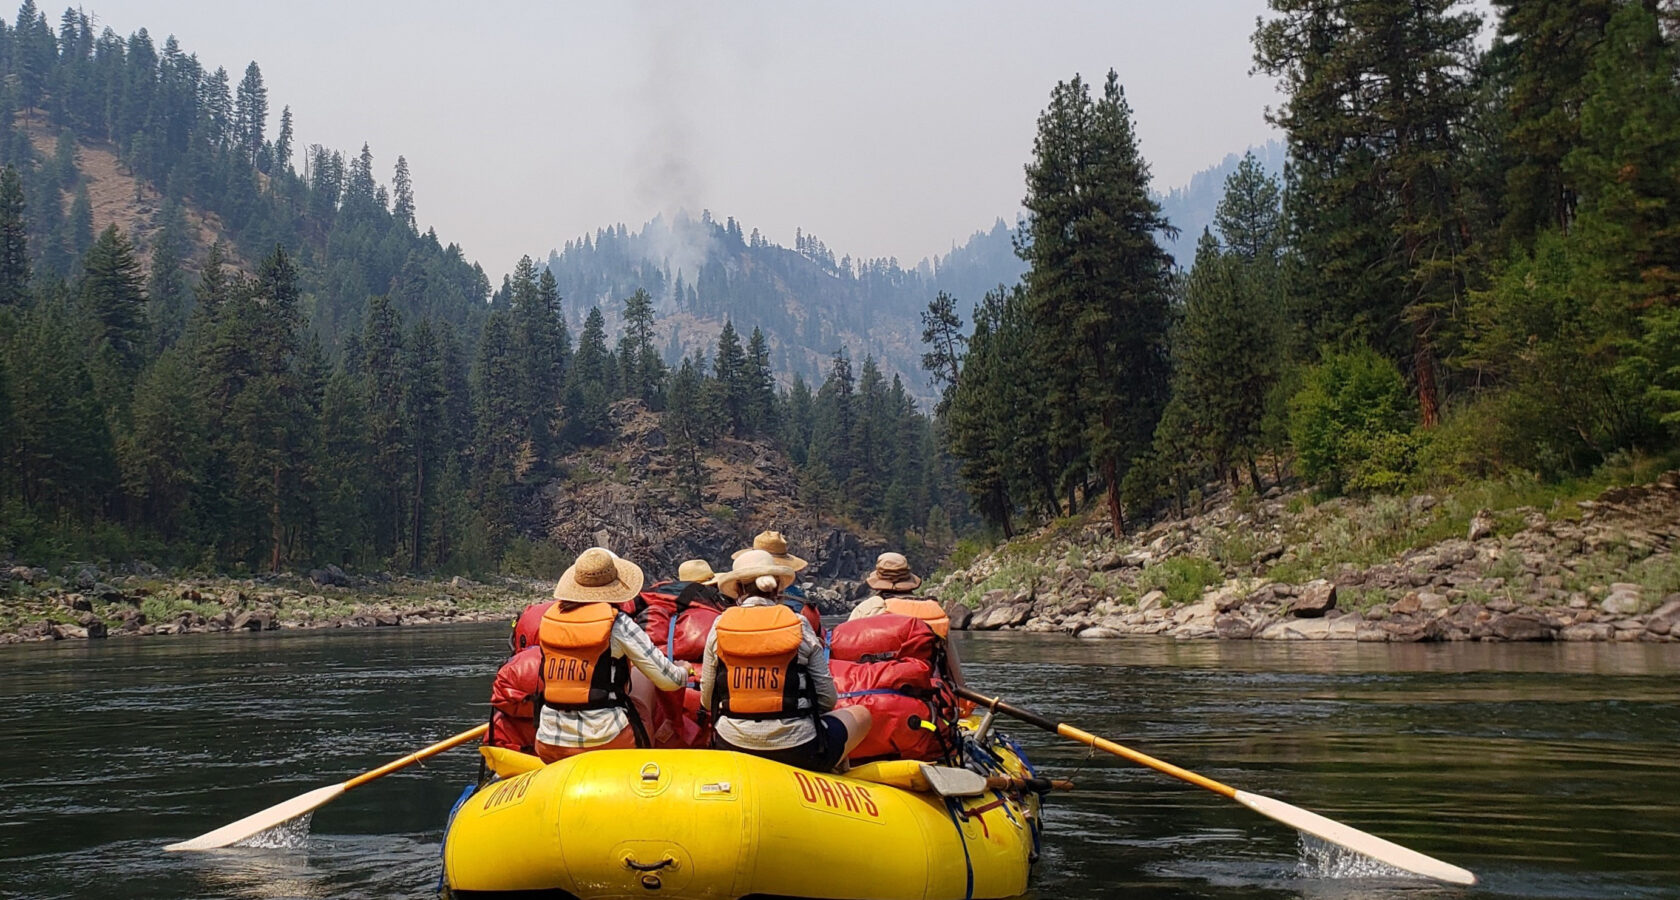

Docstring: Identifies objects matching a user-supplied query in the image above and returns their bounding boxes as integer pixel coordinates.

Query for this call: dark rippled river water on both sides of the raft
[0,626,1680,900]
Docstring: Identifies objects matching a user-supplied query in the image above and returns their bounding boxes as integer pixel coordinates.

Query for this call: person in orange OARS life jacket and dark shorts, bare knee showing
[701,549,870,772]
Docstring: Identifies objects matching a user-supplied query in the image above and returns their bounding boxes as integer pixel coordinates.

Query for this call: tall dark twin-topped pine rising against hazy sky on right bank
[1020,71,1174,534]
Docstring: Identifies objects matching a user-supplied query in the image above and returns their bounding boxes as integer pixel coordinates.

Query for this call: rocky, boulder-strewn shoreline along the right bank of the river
[934,472,1680,641]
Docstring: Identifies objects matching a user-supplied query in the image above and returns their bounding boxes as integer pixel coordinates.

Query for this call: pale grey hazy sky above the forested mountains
[91,0,1278,277]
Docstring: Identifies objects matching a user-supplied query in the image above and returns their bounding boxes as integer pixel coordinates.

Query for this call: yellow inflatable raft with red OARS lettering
[444,735,1038,900]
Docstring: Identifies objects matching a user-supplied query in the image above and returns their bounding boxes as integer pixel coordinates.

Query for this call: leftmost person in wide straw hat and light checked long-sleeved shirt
[536,547,689,762]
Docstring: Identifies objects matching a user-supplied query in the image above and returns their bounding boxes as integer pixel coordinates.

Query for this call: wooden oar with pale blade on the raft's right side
[956,687,1475,885]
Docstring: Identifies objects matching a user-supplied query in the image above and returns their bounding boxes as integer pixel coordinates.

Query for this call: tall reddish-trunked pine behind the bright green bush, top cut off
[1255,0,1480,425]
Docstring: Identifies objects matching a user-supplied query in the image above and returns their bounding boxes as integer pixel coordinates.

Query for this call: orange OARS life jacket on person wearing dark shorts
[714,604,818,719]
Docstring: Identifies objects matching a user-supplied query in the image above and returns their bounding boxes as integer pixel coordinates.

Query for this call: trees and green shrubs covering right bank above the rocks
[931,0,1680,540]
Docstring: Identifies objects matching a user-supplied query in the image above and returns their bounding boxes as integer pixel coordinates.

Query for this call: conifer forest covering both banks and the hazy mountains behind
[0,0,1680,573]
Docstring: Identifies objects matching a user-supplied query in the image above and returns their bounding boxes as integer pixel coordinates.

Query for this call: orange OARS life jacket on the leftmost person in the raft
[538,603,630,710]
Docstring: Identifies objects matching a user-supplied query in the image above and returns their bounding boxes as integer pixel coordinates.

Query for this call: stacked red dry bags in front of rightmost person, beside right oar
[828,613,958,761]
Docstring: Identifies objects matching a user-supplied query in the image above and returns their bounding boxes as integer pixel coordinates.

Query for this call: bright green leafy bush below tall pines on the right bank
[1289,348,1421,492]
